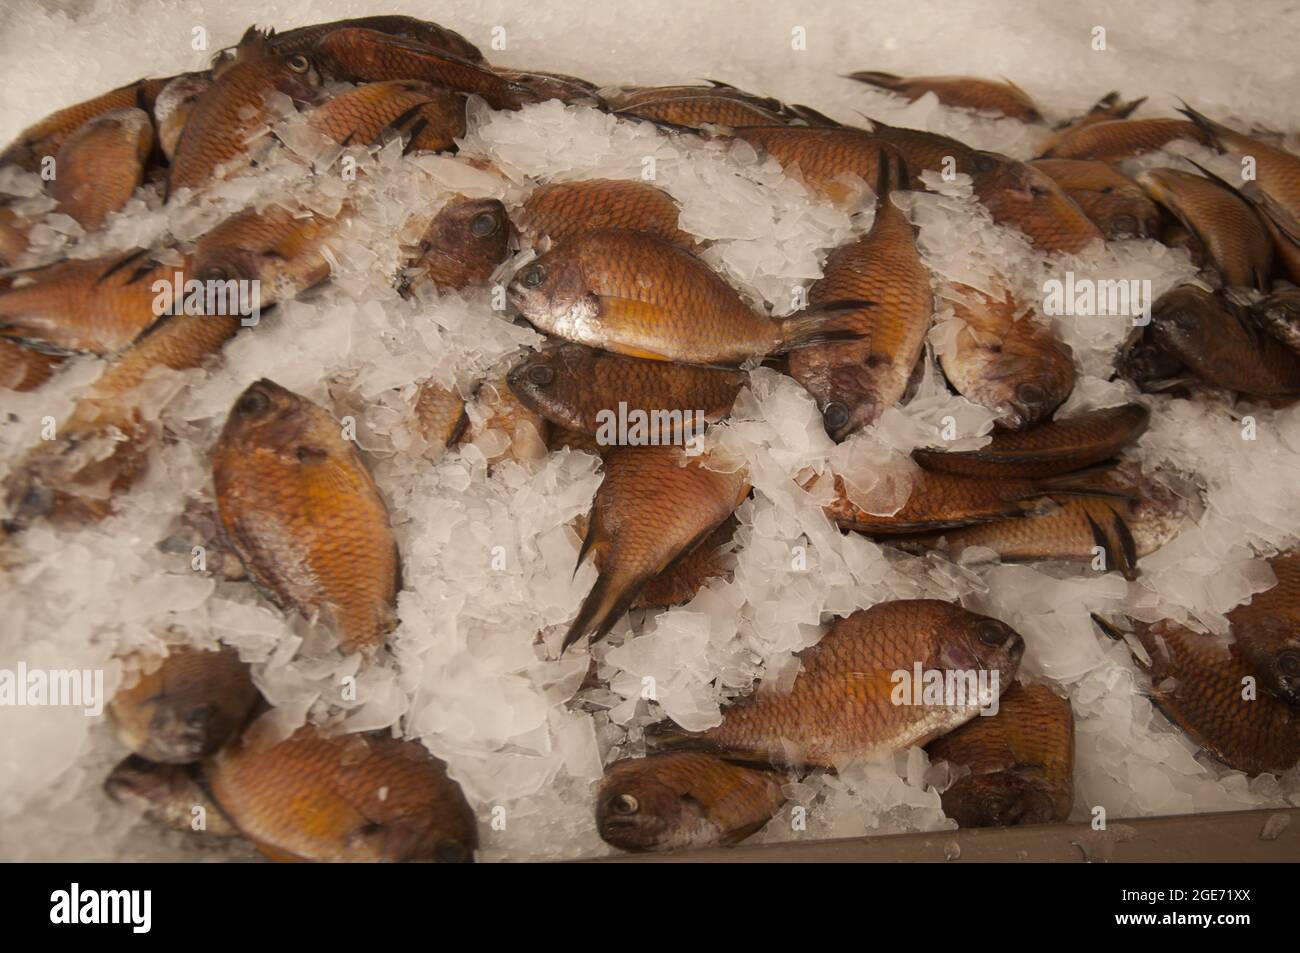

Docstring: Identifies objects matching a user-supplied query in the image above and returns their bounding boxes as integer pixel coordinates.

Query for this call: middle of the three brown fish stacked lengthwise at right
[826,469,1122,536]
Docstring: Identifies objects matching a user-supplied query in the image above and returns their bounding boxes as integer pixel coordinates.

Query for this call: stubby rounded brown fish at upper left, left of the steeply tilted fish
[49,108,153,231]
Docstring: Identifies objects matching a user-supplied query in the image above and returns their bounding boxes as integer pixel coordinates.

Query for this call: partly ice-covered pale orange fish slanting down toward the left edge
[4,313,241,532]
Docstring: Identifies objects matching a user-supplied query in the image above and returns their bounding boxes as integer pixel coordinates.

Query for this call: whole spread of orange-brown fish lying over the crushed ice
[0,16,1300,861]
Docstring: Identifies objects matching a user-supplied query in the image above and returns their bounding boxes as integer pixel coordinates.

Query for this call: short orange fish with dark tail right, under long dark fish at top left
[307,79,465,152]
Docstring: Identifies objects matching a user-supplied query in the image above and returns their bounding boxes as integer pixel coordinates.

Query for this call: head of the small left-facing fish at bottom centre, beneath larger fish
[595,771,709,852]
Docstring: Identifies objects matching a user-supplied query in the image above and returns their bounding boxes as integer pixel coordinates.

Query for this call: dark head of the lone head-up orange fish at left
[221,378,335,463]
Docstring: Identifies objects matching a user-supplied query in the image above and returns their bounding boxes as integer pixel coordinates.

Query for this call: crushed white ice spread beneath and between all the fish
[0,0,1300,859]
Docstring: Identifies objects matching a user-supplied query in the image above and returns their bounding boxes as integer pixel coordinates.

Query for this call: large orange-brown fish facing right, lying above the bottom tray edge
[646,599,1024,768]
